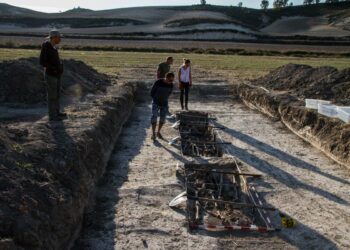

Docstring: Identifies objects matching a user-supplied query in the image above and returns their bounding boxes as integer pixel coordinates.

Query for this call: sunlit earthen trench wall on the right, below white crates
[234,83,350,168]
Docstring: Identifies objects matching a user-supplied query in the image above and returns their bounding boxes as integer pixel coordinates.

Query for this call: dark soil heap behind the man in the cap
[0,58,110,104]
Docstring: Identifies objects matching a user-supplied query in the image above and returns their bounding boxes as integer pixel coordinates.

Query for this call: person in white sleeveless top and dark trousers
[179,59,192,110]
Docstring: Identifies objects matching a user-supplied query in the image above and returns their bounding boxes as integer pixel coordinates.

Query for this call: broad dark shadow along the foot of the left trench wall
[73,93,151,250]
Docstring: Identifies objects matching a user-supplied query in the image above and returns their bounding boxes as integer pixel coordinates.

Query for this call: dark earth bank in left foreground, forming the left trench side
[0,83,137,249]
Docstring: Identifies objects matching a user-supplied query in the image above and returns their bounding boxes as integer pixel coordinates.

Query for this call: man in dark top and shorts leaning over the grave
[151,73,175,140]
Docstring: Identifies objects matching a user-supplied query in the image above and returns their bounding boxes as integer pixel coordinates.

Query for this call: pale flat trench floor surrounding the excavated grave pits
[75,79,350,249]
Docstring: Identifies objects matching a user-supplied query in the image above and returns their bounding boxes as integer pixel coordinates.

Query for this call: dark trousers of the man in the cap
[45,74,61,120]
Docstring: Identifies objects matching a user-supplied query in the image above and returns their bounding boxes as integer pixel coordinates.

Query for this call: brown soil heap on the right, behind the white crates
[253,64,350,105]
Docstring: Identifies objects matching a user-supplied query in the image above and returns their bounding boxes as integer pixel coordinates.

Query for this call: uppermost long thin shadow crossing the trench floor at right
[217,123,350,185]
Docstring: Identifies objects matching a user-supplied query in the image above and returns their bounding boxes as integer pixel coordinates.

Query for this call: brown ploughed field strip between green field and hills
[0,35,350,54]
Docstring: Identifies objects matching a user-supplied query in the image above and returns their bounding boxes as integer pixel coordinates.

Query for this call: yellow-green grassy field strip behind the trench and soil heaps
[0,49,350,79]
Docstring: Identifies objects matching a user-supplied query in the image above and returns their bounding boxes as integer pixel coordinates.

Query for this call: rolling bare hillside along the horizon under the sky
[0,3,350,40]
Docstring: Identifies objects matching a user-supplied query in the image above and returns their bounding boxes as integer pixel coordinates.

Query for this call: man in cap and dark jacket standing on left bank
[40,30,67,121]
